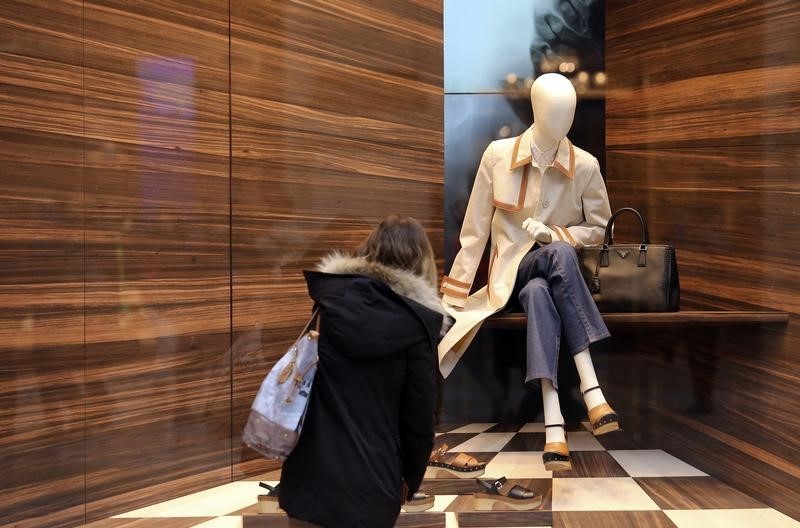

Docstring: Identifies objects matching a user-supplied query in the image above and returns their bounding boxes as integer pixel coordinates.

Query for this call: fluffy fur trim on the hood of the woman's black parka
[310,252,450,336]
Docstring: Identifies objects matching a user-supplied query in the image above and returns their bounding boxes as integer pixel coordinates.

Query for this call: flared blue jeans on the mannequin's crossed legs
[512,241,611,388]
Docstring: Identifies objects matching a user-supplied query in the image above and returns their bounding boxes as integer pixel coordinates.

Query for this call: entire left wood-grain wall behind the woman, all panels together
[0,0,443,528]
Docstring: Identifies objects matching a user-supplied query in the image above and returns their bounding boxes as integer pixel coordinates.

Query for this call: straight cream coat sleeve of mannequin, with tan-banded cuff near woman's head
[441,143,494,307]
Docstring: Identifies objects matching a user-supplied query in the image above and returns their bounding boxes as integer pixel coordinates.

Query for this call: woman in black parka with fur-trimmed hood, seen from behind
[280,217,444,528]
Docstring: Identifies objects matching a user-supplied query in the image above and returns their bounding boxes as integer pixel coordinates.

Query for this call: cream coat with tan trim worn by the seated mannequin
[439,128,611,377]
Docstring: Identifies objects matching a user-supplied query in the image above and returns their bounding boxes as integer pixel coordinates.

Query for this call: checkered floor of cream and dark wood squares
[103,423,800,528]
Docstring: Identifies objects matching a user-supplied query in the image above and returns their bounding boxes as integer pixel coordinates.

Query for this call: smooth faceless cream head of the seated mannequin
[531,73,577,150]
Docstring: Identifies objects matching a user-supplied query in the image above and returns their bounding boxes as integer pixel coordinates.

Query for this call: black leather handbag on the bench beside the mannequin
[580,207,680,313]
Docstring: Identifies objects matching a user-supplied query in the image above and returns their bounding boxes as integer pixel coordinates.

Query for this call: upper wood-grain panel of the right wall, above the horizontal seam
[606,0,800,148]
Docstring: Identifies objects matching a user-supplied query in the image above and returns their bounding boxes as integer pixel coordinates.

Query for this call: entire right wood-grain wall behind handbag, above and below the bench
[606,0,800,517]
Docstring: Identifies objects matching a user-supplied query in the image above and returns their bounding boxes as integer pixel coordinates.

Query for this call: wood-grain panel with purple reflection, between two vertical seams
[84,0,230,521]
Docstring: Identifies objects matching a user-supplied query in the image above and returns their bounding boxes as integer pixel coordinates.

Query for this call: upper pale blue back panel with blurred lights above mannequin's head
[444,0,605,93]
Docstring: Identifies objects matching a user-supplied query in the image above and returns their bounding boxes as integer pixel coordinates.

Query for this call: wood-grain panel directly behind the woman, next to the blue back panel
[231,0,443,476]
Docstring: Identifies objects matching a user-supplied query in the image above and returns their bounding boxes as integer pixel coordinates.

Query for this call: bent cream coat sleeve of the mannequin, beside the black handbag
[547,159,611,249]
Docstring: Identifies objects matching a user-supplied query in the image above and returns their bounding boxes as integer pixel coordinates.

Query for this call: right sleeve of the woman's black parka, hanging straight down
[400,341,436,499]
